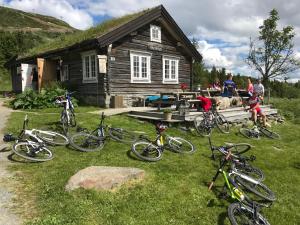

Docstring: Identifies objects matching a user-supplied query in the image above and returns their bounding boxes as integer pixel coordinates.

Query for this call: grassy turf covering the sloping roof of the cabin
[19,8,154,58]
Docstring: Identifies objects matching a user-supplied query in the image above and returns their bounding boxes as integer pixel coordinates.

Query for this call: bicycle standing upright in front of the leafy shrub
[55,92,76,135]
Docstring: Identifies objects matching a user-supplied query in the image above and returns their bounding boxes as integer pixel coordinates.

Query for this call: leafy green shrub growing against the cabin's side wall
[11,84,78,109]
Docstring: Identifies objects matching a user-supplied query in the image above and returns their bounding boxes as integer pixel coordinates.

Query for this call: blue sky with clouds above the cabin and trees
[0,0,300,81]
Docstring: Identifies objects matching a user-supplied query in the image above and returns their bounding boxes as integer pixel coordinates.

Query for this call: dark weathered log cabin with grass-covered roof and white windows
[6,5,202,107]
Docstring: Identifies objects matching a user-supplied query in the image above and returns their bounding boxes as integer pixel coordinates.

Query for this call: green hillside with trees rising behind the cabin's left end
[0,6,77,92]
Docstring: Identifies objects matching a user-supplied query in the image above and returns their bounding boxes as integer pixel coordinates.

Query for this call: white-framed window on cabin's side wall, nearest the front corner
[81,51,98,83]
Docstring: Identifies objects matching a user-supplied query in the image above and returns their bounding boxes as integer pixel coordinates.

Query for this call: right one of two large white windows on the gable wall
[163,56,179,84]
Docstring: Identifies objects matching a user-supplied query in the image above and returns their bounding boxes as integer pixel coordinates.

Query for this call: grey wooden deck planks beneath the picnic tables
[128,105,278,123]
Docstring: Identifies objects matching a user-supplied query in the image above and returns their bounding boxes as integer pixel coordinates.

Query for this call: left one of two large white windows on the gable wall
[130,52,151,83]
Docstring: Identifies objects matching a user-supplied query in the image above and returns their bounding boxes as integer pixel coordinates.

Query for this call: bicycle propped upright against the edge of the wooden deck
[194,107,230,137]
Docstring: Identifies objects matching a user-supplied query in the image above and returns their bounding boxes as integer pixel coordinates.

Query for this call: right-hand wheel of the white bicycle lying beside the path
[36,130,69,145]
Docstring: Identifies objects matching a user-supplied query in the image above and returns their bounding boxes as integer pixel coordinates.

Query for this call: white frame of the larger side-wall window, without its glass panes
[81,51,98,83]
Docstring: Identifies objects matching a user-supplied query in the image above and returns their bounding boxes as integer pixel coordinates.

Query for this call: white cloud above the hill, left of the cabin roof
[6,0,93,29]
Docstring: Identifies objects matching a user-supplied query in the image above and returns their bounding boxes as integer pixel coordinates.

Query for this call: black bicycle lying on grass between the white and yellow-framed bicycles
[70,112,137,152]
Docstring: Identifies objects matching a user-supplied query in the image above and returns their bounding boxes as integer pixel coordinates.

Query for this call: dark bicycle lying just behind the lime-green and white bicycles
[208,137,265,181]
